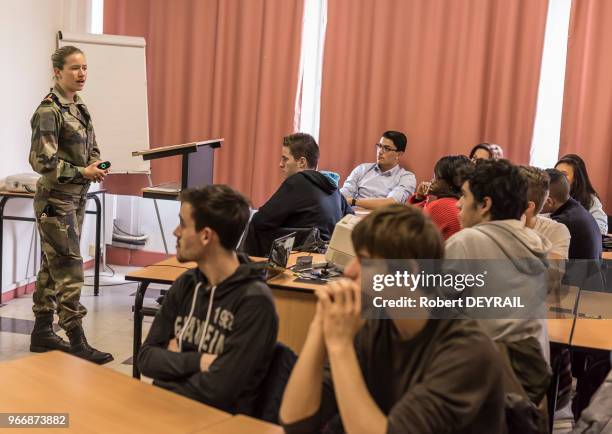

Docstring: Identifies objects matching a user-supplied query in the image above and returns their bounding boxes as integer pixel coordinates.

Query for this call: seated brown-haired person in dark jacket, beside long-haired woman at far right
[543,169,602,259]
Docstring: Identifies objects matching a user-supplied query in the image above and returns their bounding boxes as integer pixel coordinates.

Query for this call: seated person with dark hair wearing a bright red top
[408,155,473,240]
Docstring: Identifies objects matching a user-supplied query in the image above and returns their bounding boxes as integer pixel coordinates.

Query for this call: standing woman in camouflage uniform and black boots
[30,46,113,364]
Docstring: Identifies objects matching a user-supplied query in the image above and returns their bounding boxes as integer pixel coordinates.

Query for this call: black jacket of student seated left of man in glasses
[247,170,354,256]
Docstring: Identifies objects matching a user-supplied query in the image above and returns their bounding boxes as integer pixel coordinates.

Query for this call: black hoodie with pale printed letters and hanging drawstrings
[138,258,278,414]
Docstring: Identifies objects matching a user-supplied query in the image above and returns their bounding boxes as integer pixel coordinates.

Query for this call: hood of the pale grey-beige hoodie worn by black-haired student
[473,219,552,275]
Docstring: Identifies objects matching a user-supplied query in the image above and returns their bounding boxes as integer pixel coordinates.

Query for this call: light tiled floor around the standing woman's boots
[0,266,166,375]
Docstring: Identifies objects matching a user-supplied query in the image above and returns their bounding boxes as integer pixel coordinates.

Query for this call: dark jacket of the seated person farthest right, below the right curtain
[550,198,602,259]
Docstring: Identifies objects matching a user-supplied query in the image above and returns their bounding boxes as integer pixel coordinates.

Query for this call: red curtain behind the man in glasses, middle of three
[320,0,548,185]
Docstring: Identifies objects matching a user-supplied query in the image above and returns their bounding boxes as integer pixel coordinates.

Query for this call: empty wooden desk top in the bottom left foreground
[0,351,232,434]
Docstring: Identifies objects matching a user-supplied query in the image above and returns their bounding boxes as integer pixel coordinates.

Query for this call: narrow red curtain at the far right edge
[559,0,612,214]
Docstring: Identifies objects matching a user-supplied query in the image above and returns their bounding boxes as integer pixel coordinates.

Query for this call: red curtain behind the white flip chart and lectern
[104,0,303,206]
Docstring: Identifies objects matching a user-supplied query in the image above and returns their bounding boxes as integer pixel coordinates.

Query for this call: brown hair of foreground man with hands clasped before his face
[351,204,444,259]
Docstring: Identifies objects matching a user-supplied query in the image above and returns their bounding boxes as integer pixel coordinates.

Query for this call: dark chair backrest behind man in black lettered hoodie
[255,342,297,423]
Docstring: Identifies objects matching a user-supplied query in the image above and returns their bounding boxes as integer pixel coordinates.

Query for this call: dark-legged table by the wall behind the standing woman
[0,189,106,305]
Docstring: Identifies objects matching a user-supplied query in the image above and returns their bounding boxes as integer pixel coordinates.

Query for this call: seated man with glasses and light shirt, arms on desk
[340,131,416,209]
